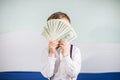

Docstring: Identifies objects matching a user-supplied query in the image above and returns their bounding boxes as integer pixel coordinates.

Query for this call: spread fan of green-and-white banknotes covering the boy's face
[42,19,77,42]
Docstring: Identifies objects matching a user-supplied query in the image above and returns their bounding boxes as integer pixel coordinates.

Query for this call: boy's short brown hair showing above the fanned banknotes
[47,12,71,23]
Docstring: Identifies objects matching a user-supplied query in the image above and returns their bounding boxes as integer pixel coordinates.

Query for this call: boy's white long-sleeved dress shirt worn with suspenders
[41,46,81,80]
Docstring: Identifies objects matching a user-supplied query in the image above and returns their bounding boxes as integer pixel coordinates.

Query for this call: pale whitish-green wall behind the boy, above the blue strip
[0,0,120,72]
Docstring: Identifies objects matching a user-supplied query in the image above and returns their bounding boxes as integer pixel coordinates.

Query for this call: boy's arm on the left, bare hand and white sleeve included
[41,41,58,78]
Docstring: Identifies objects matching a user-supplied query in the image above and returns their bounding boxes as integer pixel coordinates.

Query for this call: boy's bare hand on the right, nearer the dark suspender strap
[59,39,69,57]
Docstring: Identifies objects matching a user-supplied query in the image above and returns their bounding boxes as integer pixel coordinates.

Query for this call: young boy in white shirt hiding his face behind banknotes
[41,12,81,80]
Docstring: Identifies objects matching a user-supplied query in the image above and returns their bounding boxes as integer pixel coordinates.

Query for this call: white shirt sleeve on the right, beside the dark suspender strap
[62,48,81,78]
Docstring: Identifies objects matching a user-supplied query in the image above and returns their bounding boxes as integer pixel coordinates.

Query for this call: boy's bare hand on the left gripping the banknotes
[49,41,58,57]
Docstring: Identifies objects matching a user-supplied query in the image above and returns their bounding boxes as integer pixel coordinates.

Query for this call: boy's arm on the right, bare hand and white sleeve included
[60,40,81,77]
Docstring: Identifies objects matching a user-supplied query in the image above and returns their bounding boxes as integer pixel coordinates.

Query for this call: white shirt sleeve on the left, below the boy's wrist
[41,52,56,78]
